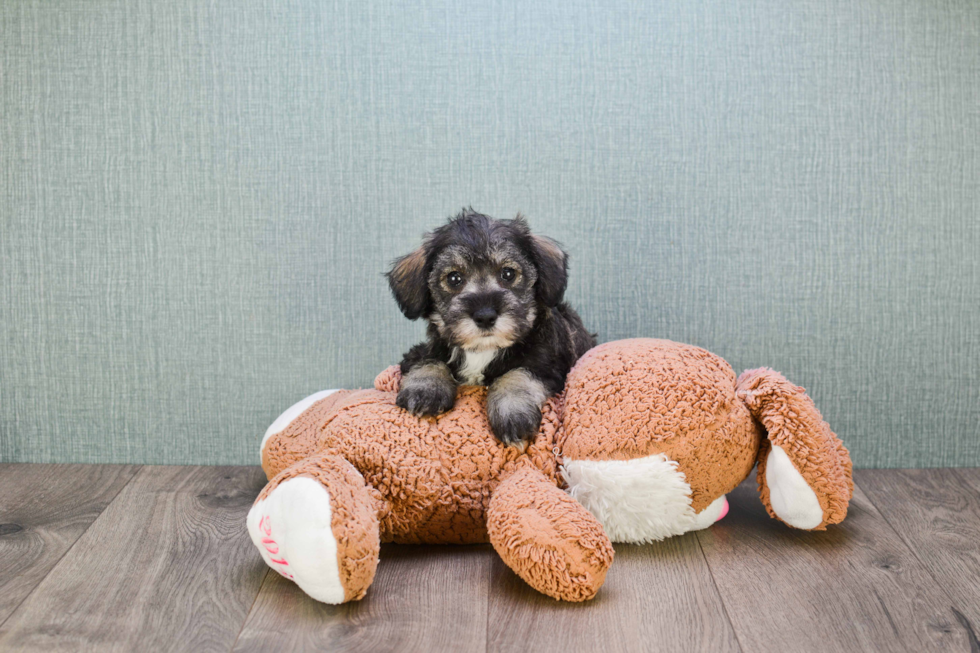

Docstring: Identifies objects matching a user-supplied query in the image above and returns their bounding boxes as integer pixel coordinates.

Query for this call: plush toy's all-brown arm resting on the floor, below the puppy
[487,469,613,601]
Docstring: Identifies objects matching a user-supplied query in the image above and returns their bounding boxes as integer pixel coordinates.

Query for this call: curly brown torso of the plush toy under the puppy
[263,386,561,544]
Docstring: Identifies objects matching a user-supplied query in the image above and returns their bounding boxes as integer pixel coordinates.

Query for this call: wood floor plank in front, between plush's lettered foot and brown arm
[234,544,496,652]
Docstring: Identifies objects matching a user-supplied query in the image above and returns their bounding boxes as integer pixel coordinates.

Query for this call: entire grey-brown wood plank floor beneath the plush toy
[0,465,980,653]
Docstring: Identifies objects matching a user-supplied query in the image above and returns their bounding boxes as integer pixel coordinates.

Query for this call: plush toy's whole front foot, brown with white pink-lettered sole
[247,456,380,604]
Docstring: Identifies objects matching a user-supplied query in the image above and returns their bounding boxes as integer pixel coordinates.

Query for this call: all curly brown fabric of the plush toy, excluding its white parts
[253,338,853,601]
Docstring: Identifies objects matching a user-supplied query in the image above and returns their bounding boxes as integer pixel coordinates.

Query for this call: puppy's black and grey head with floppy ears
[387,209,568,351]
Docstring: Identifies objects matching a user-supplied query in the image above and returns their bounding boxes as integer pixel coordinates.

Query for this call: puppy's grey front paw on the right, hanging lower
[487,368,547,449]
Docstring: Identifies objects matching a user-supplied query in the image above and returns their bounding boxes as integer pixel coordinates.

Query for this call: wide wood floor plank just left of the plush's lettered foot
[0,467,266,651]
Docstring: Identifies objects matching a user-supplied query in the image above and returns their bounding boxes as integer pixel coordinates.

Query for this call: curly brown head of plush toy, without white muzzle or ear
[562,338,762,512]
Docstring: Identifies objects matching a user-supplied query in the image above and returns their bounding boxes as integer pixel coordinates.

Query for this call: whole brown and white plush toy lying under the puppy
[248,339,853,603]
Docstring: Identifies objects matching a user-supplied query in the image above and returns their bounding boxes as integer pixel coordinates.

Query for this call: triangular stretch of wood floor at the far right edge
[855,469,980,640]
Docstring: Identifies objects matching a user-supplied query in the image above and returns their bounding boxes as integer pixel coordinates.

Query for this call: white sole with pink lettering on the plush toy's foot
[247,476,344,604]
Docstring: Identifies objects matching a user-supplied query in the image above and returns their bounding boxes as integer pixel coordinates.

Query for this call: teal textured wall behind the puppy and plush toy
[0,0,980,466]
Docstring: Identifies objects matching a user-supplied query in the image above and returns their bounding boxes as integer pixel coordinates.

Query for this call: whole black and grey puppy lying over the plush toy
[387,209,596,447]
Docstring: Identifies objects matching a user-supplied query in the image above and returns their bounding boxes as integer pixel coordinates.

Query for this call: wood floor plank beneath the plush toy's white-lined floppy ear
[698,475,970,652]
